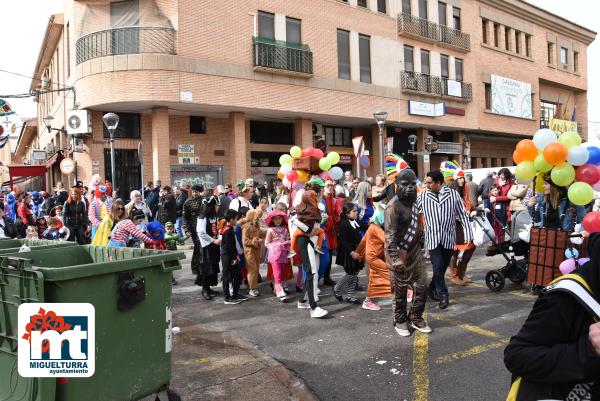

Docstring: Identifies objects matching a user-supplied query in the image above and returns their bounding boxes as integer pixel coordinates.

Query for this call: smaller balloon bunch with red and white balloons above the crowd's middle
[277,146,344,188]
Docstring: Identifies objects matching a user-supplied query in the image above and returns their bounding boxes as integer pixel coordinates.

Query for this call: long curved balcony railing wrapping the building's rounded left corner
[75,26,175,64]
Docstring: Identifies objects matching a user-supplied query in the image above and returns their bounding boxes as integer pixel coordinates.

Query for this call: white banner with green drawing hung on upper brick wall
[491,75,533,118]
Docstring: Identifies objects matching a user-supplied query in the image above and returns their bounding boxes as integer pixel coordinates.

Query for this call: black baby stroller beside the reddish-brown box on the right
[482,211,531,292]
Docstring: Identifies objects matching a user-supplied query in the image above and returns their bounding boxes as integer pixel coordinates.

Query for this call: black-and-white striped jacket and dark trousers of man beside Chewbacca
[416,186,473,297]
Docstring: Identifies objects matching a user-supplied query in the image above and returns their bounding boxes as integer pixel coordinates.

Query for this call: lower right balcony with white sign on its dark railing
[400,71,473,102]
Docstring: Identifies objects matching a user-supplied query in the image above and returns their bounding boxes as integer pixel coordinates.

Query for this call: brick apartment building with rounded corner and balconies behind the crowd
[24,0,596,192]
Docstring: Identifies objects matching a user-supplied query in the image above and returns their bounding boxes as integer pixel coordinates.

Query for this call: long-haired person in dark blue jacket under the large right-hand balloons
[528,173,585,231]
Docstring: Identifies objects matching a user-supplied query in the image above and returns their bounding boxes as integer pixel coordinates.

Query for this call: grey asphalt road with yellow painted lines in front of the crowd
[173,248,535,401]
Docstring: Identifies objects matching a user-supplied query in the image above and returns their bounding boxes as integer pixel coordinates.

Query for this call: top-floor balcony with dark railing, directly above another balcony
[398,13,471,52]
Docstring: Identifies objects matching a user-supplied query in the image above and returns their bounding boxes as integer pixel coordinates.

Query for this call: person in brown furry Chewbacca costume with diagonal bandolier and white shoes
[385,169,431,337]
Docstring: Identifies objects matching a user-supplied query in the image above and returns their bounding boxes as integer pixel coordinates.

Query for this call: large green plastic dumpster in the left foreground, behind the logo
[0,245,185,401]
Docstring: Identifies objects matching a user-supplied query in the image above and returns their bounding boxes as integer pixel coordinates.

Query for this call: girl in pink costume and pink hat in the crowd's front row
[265,210,290,300]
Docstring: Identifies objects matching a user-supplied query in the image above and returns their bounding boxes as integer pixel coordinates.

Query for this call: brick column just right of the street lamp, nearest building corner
[152,107,171,185]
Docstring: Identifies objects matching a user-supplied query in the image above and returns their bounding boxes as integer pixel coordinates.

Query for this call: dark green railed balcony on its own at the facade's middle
[253,37,313,78]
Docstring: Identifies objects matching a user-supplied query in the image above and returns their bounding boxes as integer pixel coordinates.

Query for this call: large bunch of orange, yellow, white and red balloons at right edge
[513,128,600,206]
